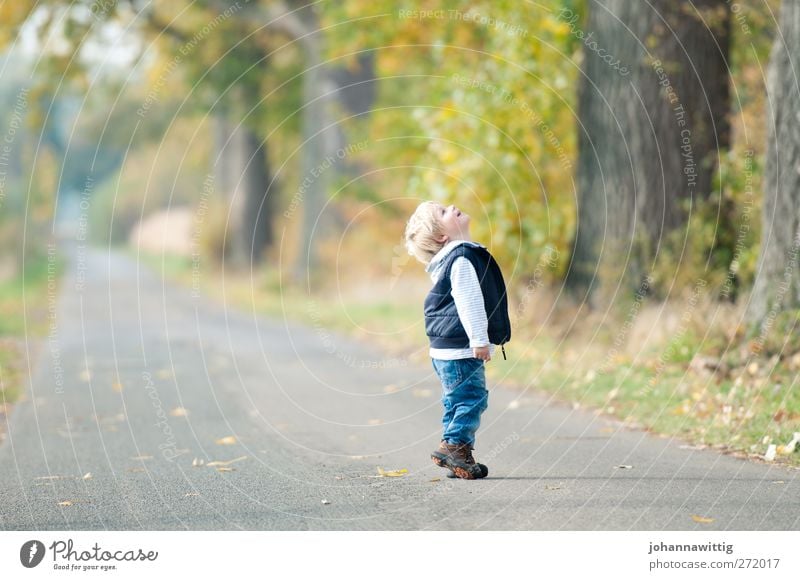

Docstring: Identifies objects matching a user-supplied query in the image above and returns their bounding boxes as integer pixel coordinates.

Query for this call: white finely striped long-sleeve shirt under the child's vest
[426,240,494,360]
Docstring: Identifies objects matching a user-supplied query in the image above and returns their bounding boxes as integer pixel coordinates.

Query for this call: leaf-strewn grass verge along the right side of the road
[143,249,800,467]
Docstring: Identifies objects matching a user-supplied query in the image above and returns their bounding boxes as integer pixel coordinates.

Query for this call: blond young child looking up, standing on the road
[405,201,511,479]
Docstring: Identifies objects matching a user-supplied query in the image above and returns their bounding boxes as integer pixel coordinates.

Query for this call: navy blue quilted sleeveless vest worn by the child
[425,244,511,348]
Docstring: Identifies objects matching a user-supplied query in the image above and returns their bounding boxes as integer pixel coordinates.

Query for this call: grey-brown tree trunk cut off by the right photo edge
[747,0,800,332]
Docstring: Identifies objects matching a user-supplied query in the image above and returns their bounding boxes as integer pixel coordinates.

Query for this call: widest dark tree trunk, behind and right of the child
[562,0,730,299]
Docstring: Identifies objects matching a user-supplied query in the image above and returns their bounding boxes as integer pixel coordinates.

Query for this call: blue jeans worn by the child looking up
[431,358,489,445]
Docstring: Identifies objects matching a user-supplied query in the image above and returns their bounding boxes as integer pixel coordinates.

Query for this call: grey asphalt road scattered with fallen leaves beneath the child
[0,240,800,530]
